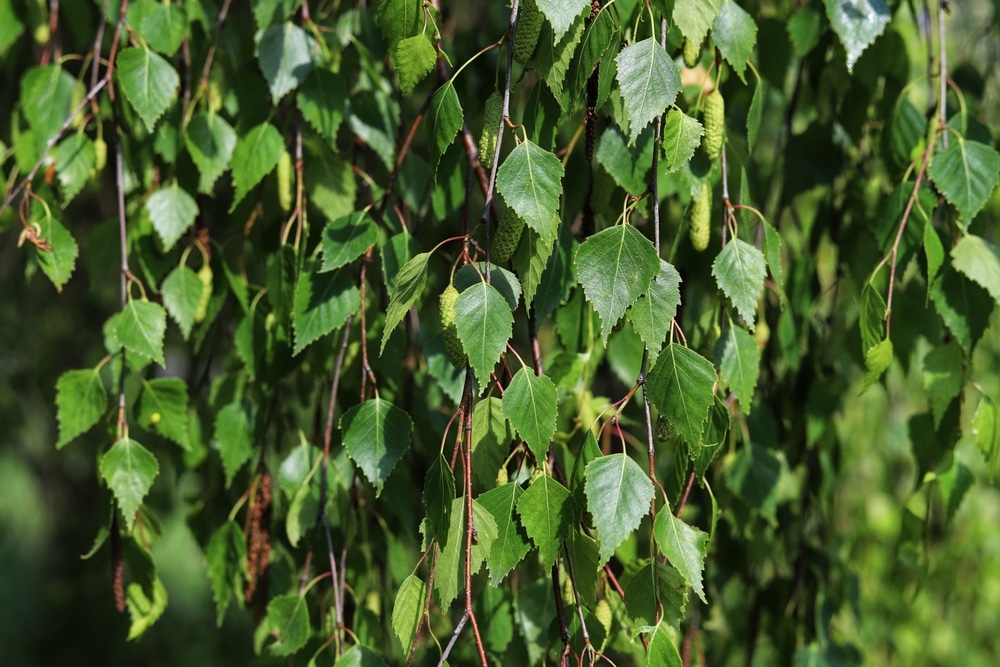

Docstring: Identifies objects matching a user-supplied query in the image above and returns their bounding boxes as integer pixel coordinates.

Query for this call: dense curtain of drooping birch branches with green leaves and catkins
[0,0,1000,665]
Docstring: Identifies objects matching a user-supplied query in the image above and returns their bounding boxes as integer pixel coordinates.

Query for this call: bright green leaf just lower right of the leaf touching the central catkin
[503,366,557,461]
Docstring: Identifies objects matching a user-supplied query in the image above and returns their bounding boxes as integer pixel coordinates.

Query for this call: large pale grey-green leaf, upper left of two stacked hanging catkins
[615,37,680,144]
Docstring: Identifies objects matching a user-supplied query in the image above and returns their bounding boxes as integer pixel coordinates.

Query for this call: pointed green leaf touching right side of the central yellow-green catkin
[455,283,514,386]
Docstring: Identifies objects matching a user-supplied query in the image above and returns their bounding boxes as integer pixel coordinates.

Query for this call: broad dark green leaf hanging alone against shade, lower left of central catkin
[340,397,413,497]
